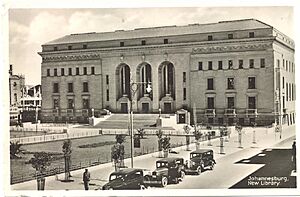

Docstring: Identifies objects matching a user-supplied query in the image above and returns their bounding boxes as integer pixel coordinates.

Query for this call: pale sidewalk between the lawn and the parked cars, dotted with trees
[11,126,295,190]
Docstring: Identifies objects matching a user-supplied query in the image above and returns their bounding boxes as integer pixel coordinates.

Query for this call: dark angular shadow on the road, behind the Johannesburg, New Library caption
[230,148,296,189]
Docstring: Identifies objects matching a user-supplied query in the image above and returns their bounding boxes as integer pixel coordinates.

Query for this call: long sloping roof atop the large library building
[44,19,272,45]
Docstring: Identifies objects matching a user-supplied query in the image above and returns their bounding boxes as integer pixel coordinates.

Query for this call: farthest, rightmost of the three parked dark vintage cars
[185,149,216,174]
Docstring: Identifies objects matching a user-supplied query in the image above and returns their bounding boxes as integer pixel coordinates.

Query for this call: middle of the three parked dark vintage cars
[144,157,185,187]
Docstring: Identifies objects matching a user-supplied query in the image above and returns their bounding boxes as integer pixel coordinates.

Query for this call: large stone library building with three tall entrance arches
[39,19,295,125]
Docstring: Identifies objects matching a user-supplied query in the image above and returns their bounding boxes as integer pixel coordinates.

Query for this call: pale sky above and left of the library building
[8,6,295,85]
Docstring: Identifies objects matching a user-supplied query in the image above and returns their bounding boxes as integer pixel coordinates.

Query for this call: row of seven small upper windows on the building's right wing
[198,58,266,70]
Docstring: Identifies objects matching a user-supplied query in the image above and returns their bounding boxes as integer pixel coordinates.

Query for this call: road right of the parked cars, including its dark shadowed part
[166,138,296,189]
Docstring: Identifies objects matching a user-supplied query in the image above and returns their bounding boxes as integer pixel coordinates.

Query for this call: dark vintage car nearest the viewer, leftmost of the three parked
[102,168,151,190]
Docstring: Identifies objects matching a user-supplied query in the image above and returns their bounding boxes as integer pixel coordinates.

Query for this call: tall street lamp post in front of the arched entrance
[130,82,152,168]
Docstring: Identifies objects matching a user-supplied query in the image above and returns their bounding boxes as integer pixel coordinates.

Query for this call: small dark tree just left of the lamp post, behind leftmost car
[111,135,126,171]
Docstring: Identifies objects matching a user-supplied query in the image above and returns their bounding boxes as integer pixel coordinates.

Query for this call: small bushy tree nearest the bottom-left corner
[29,152,52,190]
